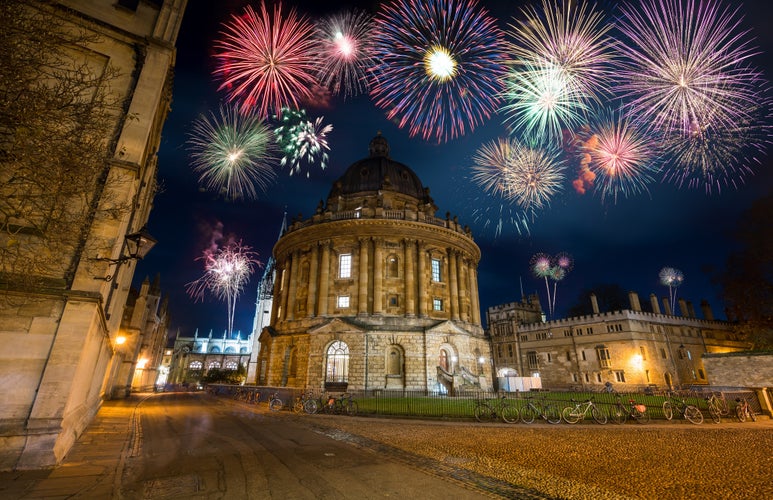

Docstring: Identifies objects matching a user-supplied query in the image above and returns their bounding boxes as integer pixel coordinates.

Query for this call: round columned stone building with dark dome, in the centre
[256,134,492,393]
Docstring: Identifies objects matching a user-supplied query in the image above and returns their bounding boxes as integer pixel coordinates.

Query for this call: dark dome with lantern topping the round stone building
[328,132,428,201]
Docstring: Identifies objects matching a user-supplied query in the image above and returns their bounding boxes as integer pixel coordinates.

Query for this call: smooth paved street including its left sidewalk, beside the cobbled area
[0,393,547,500]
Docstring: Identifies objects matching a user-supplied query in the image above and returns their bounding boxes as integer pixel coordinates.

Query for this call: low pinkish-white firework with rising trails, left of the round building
[185,242,261,336]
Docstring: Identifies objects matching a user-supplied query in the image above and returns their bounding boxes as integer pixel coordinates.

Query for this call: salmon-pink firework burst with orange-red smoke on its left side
[575,112,658,203]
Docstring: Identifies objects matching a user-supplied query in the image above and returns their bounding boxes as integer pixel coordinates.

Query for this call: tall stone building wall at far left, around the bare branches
[0,0,186,470]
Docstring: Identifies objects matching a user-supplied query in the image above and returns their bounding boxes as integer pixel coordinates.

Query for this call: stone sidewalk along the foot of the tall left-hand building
[0,394,147,500]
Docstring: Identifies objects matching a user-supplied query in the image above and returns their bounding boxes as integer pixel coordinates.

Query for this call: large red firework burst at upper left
[214,2,318,118]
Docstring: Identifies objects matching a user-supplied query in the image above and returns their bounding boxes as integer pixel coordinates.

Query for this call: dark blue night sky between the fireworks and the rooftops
[134,0,773,335]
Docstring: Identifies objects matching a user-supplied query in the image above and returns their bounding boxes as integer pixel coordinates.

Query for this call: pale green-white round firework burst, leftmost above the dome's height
[188,107,276,199]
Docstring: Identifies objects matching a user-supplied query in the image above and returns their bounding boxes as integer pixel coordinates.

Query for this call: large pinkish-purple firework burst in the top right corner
[617,0,760,136]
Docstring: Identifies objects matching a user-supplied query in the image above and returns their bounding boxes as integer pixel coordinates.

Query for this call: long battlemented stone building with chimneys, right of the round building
[488,292,748,390]
